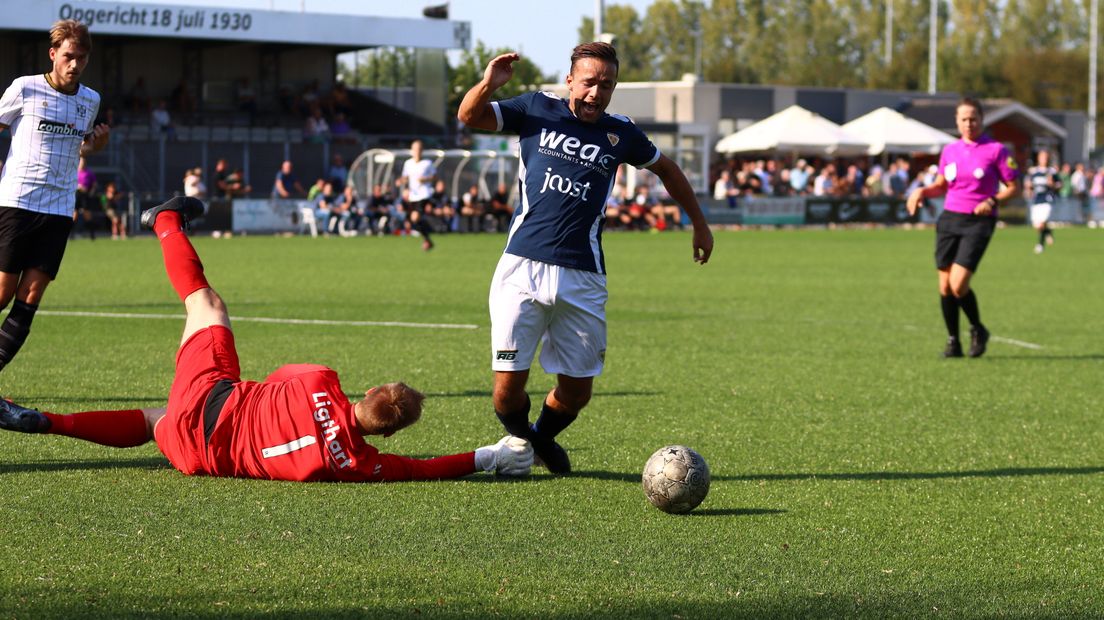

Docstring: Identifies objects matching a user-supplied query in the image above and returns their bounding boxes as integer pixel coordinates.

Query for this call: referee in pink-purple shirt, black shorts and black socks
[907,97,1019,357]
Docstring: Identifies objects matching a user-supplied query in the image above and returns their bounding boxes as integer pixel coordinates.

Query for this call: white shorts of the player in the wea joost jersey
[490,254,608,377]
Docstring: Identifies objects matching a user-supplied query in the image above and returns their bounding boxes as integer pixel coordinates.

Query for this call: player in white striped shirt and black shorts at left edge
[0,20,109,368]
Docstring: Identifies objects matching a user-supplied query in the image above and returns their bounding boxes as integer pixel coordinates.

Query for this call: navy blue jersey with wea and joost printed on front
[491,93,659,274]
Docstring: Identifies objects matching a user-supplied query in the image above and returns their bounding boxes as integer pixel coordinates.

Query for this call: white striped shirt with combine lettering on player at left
[0,74,99,216]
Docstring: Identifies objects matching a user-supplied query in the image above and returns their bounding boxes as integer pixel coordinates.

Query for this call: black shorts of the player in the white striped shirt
[0,206,73,279]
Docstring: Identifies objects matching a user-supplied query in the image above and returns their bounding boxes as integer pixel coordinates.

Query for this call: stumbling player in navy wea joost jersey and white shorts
[457,43,713,473]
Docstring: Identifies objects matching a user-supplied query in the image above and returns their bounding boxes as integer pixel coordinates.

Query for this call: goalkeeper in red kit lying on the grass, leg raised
[0,197,533,482]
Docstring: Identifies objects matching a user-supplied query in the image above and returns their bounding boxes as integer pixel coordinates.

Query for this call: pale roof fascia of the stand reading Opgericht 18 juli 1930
[0,0,471,50]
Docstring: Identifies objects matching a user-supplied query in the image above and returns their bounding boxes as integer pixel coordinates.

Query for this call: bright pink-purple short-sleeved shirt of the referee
[940,135,1019,217]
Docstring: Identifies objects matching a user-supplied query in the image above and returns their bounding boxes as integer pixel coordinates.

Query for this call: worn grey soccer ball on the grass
[643,446,709,514]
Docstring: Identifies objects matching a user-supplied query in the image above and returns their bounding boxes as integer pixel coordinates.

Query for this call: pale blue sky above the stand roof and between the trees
[137,0,652,77]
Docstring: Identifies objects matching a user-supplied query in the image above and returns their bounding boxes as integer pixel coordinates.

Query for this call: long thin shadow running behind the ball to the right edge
[571,467,1104,484]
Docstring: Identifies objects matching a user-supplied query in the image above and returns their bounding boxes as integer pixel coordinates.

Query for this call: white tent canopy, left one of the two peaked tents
[716,106,870,156]
